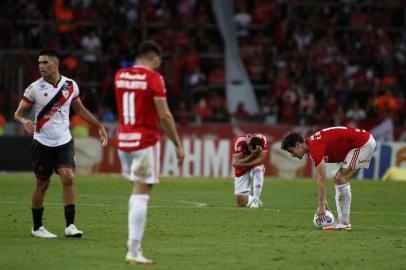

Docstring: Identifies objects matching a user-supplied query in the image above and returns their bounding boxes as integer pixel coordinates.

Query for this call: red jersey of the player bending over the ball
[306,127,371,167]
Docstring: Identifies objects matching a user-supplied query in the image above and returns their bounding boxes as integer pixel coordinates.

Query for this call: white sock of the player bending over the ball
[335,183,352,224]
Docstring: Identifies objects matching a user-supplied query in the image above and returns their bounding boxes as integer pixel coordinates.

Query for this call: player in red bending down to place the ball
[281,127,376,231]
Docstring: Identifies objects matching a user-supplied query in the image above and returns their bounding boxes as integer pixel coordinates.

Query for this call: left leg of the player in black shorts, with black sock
[31,140,56,238]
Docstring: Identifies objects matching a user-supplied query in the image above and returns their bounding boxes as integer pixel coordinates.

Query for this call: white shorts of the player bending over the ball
[340,135,376,169]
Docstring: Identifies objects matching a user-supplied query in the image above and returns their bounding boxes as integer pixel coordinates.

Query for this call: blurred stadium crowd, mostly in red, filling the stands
[0,0,406,129]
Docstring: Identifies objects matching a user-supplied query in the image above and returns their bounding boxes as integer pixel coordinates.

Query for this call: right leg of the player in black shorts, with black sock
[55,140,83,238]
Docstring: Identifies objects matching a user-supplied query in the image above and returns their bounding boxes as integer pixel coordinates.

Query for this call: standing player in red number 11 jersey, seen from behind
[114,41,184,264]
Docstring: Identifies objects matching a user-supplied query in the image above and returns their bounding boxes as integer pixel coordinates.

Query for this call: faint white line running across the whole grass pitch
[0,200,406,216]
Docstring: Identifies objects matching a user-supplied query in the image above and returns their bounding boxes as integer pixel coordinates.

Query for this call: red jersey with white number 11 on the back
[114,66,166,151]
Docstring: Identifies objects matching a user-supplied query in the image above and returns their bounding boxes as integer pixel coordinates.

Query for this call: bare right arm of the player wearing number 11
[154,98,185,166]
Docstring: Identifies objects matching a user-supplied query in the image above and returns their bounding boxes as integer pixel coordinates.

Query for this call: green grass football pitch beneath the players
[0,174,406,270]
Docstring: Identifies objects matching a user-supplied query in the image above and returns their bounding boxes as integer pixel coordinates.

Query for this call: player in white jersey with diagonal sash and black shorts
[14,50,107,238]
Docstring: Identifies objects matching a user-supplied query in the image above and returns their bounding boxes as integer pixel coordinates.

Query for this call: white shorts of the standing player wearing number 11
[118,141,160,184]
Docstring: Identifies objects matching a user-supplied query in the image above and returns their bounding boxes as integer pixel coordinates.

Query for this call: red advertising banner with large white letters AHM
[98,124,315,177]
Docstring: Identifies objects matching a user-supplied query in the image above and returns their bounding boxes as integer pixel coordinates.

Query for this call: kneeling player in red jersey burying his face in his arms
[232,133,269,208]
